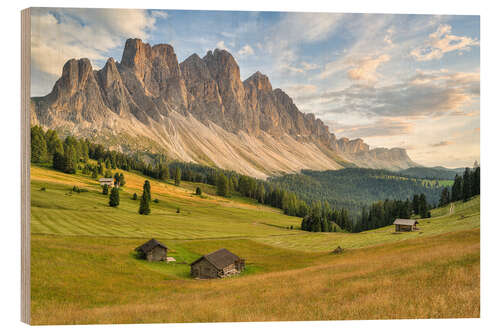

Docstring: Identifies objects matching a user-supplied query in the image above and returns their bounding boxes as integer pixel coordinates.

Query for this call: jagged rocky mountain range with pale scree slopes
[31,39,417,178]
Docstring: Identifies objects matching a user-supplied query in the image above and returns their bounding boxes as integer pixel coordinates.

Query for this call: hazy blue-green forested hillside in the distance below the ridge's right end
[269,168,442,213]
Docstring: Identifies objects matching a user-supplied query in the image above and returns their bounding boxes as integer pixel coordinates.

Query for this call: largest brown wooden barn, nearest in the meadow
[191,249,245,279]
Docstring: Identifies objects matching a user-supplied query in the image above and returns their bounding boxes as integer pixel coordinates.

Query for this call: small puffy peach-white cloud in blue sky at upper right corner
[411,24,479,61]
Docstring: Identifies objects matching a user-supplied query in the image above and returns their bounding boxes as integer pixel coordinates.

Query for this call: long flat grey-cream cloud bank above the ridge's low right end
[310,71,480,117]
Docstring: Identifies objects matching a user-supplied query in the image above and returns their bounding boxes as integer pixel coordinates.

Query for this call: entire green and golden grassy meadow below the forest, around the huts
[31,166,480,325]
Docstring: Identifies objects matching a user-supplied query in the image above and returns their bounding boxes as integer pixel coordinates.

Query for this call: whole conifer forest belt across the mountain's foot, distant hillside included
[31,126,480,232]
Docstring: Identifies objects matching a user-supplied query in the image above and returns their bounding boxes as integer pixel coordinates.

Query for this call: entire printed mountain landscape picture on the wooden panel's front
[26,8,480,325]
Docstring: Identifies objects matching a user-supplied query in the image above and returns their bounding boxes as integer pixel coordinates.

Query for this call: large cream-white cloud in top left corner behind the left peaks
[31,8,155,91]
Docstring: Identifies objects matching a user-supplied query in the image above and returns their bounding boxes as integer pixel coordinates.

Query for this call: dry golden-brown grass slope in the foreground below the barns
[32,229,480,324]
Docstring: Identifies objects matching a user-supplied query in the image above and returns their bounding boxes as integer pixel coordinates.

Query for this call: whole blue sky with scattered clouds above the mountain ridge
[31,8,480,168]
